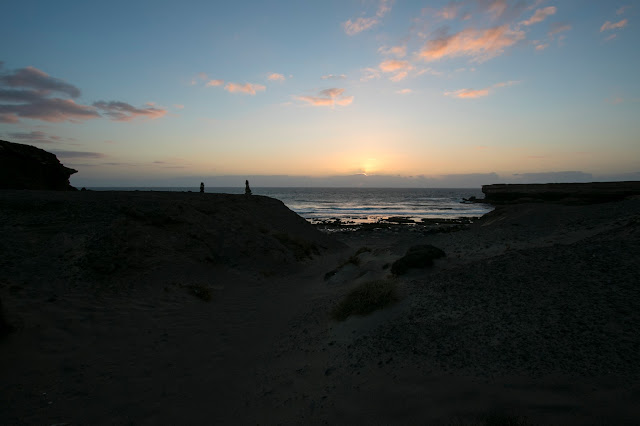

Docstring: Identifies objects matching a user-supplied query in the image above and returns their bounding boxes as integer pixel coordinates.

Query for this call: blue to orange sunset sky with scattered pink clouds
[0,0,640,187]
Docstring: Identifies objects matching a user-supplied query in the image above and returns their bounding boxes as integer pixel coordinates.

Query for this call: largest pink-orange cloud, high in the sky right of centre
[420,25,525,62]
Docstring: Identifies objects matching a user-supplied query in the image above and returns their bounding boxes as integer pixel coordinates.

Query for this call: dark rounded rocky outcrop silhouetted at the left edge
[0,140,78,191]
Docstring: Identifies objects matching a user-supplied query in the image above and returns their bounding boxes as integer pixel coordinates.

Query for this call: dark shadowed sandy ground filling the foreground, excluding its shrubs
[0,191,640,425]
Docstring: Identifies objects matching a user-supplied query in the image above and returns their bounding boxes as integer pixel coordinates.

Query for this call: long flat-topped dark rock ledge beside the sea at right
[482,181,640,204]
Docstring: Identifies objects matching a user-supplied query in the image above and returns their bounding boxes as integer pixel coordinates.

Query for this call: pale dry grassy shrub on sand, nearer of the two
[331,280,398,321]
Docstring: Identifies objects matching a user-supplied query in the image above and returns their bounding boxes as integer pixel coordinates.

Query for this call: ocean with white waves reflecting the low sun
[89,187,493,224]
